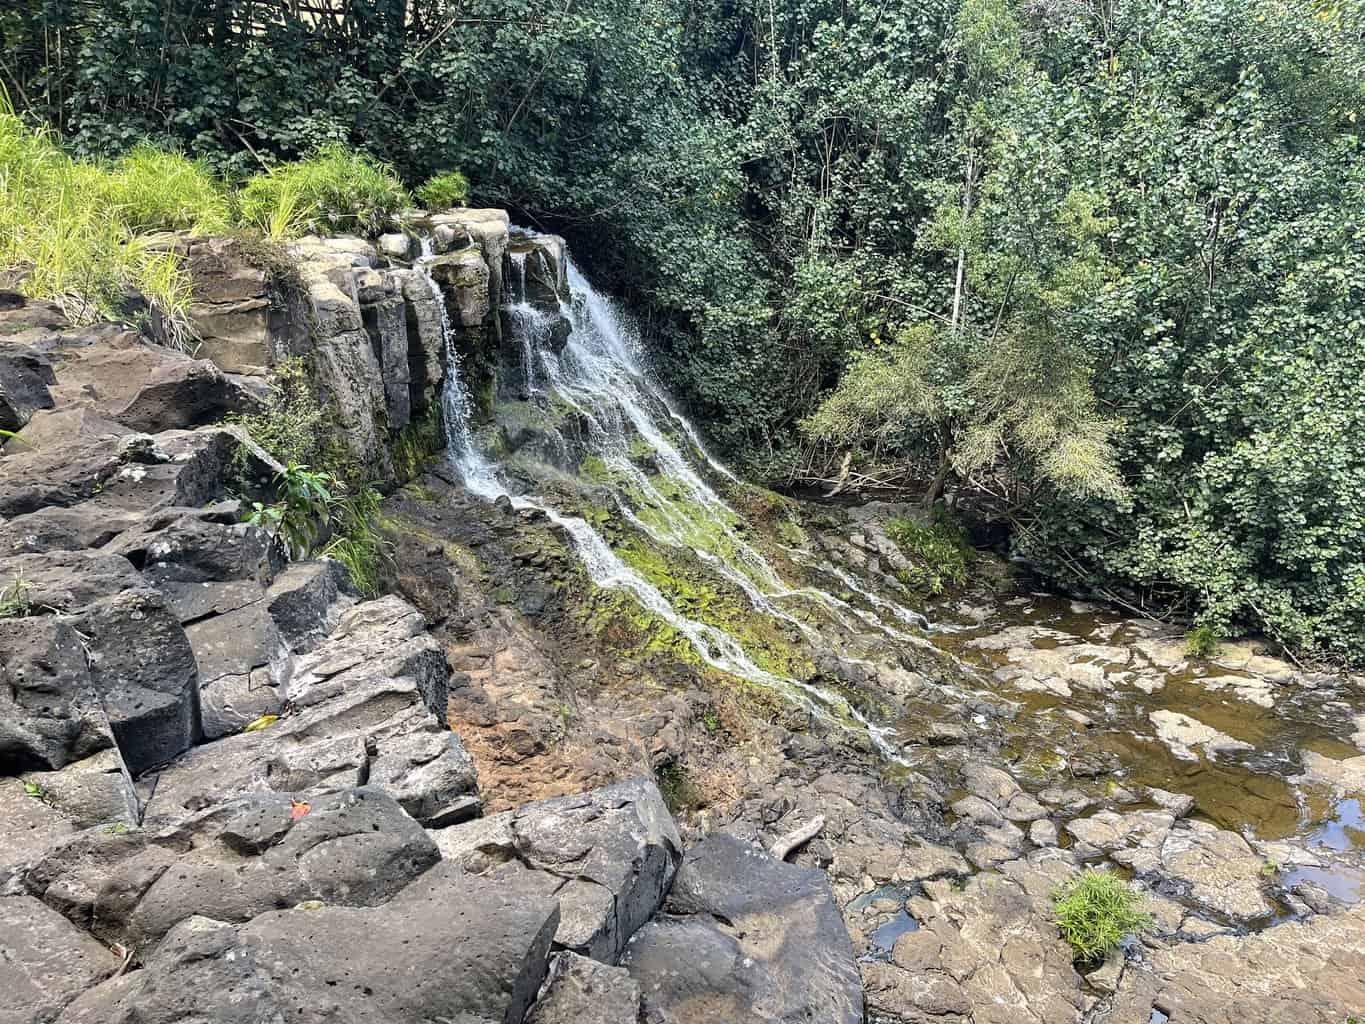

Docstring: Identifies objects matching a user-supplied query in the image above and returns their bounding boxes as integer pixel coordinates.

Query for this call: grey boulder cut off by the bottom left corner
[0,896,120,1024]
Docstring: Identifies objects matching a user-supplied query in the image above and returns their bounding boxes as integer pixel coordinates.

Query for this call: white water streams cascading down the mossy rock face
[419,232,913,760]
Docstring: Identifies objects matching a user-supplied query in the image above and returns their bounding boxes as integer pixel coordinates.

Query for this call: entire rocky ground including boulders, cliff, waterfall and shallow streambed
[0,210,1365,1024]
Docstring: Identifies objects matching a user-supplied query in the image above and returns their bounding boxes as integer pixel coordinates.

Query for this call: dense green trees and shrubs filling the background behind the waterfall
[8,0,1365,659]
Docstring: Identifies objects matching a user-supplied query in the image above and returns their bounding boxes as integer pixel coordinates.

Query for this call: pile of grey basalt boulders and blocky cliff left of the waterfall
[0,210,861,1024]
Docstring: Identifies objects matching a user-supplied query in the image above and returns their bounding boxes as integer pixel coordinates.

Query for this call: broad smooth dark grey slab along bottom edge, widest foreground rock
[60,864,558,1024]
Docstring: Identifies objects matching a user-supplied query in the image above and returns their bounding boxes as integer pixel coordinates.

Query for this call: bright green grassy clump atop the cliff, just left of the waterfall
[238,143,408,239]
